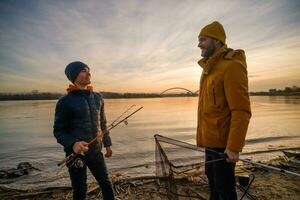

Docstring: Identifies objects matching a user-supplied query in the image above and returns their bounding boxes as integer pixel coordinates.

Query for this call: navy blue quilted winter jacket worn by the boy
[53,90,112,154]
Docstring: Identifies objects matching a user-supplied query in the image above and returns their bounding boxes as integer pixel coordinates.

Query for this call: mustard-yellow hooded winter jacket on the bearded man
[197,45,251,152]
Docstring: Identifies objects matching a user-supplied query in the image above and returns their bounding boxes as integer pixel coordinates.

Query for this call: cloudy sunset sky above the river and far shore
[0,0,300,92]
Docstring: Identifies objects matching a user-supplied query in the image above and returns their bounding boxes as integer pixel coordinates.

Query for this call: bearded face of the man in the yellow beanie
[198,36,217,58]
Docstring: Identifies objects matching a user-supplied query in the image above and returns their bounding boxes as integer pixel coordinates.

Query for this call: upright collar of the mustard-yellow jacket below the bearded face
[198,44,227,74]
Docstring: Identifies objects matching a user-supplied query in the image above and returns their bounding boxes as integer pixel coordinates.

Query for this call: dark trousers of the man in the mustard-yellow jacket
[205,148,237,200]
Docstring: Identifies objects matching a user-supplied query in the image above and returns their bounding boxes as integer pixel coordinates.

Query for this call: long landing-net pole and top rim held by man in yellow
[154,134,300,177]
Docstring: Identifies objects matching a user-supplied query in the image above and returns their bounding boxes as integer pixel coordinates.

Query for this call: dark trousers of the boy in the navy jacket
[69,144,115,200]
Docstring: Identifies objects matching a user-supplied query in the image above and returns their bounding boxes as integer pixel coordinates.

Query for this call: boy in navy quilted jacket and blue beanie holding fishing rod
[53,61,115,200]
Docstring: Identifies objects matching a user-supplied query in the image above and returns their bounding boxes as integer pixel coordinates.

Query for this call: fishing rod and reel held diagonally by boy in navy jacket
[57,106,143,167]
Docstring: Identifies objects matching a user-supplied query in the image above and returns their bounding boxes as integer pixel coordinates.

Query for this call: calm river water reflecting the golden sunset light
[0,96,300,189]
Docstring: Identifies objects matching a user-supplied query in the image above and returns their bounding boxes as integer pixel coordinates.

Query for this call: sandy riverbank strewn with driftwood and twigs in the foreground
[0,156,300,200]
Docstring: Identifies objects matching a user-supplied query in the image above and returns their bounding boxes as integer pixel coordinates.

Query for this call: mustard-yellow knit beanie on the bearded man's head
[199,21,226,44]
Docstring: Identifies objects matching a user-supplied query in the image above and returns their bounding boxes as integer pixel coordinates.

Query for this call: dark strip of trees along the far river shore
[0,86,300,101]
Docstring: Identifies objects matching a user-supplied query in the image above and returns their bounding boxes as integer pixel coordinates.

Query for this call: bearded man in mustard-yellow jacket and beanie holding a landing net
[197,21,251,200]
